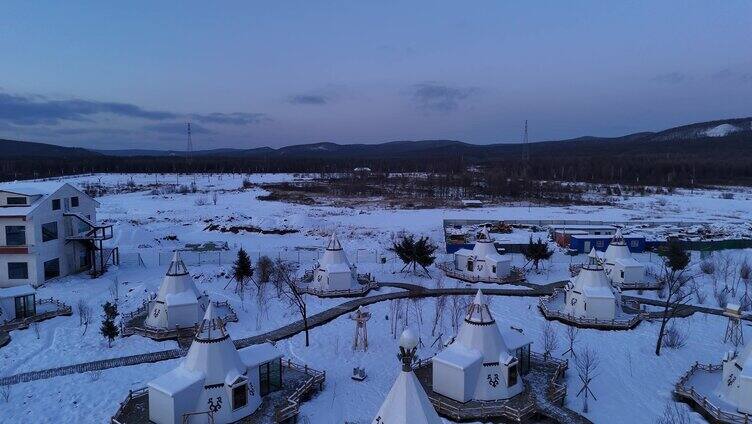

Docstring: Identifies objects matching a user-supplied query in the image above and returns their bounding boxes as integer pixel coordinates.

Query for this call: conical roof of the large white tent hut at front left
[180,303,246,386]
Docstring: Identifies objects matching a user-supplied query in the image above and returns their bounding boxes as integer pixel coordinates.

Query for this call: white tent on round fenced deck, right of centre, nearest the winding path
[564,249,619,320]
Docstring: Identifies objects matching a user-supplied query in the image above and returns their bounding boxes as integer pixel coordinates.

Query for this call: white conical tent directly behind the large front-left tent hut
[146,251,209,330]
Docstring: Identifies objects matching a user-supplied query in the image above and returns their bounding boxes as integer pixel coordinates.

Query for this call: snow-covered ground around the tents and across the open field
[0,174,752,423]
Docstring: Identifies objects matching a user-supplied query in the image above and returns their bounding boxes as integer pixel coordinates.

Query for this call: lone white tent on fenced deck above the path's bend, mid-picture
[313,233,358,291]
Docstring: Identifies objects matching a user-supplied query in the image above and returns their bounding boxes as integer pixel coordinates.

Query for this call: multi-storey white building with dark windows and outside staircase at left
[0,182,118,287]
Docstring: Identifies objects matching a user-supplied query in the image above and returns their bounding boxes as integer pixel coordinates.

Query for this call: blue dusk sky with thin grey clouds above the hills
[0,0,752,149]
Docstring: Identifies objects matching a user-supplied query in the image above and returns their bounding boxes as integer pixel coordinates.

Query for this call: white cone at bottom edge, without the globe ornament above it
[372,371,443,424]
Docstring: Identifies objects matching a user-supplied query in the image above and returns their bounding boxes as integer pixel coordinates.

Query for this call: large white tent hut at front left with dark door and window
[149,304,281,424]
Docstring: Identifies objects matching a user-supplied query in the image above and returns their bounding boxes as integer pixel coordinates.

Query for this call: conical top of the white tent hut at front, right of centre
[455,290,509,363]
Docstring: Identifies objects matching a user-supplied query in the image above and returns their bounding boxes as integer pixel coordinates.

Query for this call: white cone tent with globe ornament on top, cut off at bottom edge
[372,329,443,424]
